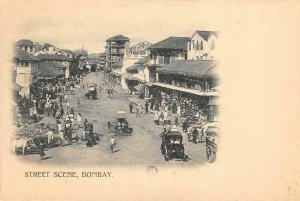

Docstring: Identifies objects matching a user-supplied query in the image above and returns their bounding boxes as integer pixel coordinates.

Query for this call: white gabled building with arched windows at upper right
[187,31,218,60]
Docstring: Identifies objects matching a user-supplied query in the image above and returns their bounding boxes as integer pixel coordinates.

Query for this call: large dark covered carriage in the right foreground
[160,131,188,161]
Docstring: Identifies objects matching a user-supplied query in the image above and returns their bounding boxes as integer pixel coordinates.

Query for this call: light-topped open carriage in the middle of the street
[107,111,133,135]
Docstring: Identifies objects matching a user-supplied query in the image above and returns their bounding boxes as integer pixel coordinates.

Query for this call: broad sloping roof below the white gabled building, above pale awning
[156,60,218,76]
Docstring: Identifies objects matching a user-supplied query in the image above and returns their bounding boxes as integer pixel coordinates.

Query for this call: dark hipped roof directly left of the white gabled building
[149,36,190,50]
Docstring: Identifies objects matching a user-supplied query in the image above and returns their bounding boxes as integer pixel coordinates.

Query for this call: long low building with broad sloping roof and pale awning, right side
[154,60,219,121]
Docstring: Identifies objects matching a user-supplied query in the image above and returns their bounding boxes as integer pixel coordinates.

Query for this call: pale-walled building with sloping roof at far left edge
[13,48,40,97]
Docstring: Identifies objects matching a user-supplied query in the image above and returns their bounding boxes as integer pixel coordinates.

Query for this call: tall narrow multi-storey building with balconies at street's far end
[105,35,129,68]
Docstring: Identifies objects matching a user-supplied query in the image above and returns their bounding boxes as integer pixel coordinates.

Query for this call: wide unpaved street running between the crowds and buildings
[19,73,206,167]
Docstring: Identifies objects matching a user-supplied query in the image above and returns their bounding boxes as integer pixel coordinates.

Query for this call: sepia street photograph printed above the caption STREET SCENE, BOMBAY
[12,30,220,166]
